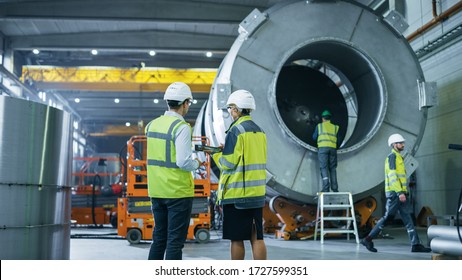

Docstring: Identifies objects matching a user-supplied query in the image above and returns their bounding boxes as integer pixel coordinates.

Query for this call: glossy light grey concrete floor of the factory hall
[70,227,432,260]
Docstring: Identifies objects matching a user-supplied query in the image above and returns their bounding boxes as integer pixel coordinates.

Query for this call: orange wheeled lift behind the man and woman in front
[117,136,216,244]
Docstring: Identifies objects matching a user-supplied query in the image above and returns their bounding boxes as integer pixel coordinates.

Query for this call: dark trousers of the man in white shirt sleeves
[148,197,193,260]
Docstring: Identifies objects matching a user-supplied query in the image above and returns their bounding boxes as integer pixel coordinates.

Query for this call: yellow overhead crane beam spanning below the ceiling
[21,66,217,93]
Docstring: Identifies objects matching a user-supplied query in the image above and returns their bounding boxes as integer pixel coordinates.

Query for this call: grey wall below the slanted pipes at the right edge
[416,40,462,218]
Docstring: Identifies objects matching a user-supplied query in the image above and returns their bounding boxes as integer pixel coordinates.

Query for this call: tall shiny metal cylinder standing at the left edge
[0,96,72,260]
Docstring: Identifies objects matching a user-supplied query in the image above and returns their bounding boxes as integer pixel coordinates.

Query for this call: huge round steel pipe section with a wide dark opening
[194,1,426,202]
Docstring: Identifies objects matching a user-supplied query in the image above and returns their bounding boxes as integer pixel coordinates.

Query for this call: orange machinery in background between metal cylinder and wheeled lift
[71,154,124,227]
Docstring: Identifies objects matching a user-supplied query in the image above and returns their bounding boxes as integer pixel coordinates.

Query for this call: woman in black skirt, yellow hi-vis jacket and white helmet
[213,90,266,260]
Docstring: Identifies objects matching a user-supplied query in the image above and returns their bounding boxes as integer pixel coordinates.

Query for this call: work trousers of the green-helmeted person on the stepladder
[318,147,338,192]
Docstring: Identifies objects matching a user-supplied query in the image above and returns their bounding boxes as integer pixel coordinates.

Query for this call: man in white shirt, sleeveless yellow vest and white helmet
[145,82,202,260]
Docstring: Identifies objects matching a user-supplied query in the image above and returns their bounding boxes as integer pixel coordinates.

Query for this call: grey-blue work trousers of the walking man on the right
[369,192,420,245]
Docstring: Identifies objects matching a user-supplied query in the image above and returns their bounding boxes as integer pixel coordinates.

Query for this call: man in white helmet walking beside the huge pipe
[361,134,431,253]
